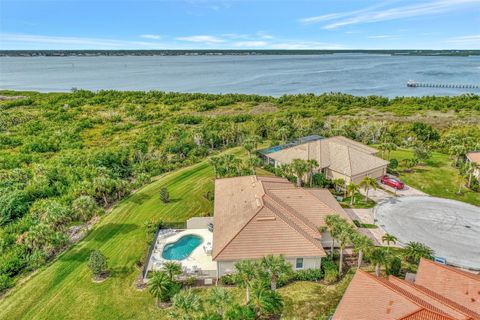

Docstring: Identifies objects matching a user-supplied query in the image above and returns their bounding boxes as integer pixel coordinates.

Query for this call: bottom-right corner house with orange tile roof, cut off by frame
[333,259,480,320]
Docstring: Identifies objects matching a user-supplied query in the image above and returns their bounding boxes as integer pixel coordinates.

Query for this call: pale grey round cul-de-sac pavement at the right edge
[374,197,480,270]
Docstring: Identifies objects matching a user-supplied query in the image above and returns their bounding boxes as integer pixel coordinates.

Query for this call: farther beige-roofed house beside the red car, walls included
[259,136,388,183]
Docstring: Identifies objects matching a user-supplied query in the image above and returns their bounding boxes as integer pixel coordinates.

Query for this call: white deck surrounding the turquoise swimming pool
[147,229,217,276]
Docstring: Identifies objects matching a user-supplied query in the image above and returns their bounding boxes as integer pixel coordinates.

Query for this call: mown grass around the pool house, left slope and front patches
[0,151,345,320]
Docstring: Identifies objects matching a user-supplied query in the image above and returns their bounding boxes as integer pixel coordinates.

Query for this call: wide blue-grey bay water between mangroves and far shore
[0,54,480,97]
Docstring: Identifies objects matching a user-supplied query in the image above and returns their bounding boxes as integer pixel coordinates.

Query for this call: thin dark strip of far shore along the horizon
[0,50,480,57]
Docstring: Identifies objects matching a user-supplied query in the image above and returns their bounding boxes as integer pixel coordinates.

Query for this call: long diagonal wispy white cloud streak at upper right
[300,0,480,29]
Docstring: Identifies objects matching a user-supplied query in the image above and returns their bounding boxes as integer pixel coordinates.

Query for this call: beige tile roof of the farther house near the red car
[267,136,388,176]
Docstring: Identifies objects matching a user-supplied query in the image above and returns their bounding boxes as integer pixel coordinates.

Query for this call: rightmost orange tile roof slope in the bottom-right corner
[415,259,480,314]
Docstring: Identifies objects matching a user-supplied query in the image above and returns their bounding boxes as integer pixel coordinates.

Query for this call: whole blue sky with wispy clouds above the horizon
[0,0,480,50]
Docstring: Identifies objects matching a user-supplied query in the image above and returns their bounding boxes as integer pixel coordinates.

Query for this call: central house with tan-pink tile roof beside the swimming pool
[212,176,351,277]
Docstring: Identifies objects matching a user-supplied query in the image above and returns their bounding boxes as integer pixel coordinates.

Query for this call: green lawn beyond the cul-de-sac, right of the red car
[391,149,480,206]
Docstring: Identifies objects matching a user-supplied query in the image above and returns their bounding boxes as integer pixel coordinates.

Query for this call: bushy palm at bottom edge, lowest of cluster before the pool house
[249,281,283,319]
